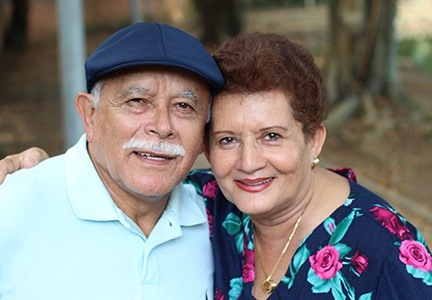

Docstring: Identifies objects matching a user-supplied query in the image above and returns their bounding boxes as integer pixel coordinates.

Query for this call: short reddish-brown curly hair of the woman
[214,32,327,137]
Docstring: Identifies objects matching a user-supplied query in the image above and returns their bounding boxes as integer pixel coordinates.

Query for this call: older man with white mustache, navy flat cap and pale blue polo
[0,23,223,300]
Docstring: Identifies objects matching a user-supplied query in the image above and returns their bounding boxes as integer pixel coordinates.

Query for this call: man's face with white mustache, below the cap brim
[86,68,210,201]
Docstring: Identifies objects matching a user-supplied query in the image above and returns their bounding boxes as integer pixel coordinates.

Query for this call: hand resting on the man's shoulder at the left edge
[0,147,49,184]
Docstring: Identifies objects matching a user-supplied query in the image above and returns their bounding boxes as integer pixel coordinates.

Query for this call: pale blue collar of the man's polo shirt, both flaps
[65,134,207,226]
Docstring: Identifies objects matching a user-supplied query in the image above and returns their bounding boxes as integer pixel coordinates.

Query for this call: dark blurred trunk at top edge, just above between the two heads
[194,0,245,45]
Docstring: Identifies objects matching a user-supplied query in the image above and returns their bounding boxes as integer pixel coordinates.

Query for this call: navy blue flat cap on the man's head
[85,23,224,94]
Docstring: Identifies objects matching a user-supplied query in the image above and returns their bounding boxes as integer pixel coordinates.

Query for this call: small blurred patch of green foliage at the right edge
[398,38,432,74]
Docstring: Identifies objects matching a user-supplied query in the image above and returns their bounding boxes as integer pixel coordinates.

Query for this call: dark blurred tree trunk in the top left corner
[3,0,29,51]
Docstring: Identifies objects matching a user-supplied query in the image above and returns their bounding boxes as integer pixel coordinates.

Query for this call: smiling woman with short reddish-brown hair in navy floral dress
[0,33,432,299]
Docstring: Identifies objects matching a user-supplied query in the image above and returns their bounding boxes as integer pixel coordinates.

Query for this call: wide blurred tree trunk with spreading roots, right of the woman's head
[323,0,416,125]
